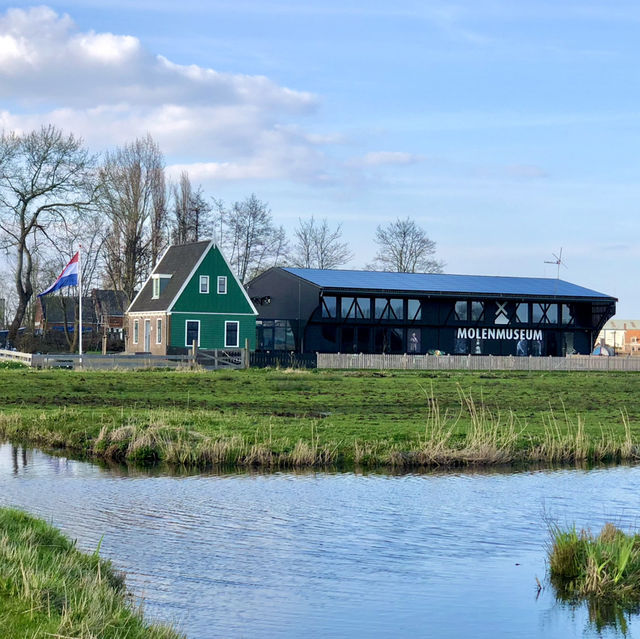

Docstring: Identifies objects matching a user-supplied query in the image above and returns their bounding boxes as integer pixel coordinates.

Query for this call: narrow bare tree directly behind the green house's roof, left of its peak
[172,171,212,244]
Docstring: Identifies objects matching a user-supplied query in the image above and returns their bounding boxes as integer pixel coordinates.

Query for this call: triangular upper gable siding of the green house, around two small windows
[171,247,255,316]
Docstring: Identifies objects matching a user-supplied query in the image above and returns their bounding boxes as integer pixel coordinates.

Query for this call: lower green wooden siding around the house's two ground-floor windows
[170,312,256,350]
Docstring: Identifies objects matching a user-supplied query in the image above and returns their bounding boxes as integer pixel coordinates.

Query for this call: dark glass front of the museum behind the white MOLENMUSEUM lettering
[252,291,608,357]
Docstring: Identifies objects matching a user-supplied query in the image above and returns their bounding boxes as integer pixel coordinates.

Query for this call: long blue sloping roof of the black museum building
[283,268,615,300]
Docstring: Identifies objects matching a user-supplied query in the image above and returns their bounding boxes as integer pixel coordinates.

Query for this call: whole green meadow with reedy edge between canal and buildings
[0,370,640,469]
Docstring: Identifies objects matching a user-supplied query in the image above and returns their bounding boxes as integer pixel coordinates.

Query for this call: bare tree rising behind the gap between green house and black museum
[216,193,287,283]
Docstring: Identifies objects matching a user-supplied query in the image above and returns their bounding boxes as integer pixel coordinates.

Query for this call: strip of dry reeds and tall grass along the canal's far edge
[0,389,639,470]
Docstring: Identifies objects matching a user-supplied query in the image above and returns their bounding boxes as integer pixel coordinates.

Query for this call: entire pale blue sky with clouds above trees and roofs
[0,0,640,318]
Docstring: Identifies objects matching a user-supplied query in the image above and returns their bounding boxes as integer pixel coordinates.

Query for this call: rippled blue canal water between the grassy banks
[0,445,640,639]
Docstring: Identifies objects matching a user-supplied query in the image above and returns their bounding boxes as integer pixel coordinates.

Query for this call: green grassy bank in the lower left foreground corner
[0,508,182,639]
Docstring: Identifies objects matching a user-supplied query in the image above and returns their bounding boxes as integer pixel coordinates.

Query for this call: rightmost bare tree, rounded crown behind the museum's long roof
[367,217,444,273]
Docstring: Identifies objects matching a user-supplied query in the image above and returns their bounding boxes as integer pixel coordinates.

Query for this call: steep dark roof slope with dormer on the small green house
[128,240,210,313]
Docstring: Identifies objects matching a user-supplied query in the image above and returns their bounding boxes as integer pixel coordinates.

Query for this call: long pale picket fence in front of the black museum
[318,353,640,371]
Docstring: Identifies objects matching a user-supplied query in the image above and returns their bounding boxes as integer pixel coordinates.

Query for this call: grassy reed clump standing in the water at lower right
[548,523,640,603]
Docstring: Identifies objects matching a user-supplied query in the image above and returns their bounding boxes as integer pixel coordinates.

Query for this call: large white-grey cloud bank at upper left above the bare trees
[0,7,330,181]
